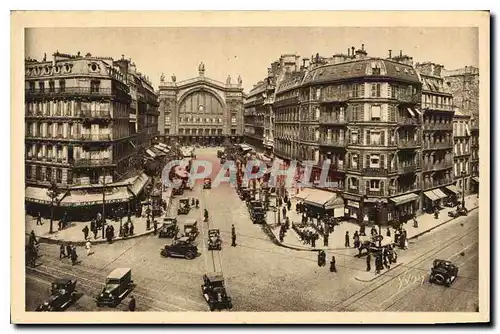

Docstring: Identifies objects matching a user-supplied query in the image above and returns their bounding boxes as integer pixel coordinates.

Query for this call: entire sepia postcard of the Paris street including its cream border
[11,12,490,323]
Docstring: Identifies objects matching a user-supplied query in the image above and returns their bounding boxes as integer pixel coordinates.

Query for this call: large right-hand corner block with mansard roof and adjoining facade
[266,46,453,223]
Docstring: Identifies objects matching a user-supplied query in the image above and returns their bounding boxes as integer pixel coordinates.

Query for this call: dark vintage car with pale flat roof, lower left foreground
[96,268,134,307]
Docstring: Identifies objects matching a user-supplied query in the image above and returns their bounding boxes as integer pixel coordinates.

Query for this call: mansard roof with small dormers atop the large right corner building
[303,58,420,84]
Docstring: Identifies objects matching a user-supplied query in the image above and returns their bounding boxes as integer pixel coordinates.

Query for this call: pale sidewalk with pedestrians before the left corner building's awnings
[25,189,173,245]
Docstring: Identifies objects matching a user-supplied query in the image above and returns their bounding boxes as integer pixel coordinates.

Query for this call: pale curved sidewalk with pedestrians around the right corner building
[267,194,479,251]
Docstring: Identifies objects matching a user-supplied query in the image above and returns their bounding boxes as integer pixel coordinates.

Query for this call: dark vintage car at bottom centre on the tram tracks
[201,273,233,311]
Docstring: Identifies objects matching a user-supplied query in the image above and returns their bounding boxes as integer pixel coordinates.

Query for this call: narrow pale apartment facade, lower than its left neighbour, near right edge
[453,111,471,194]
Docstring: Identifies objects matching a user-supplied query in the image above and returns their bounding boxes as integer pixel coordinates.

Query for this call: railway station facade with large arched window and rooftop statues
[158,63,244,146]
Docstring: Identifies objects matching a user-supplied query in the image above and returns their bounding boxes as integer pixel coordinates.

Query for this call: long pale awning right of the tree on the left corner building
[60,187,133,207]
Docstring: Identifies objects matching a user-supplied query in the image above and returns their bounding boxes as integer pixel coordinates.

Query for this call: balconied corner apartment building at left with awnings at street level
[25,52,157,217]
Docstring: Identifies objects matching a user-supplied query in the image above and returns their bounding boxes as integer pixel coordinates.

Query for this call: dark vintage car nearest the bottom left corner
[36,278,76,312]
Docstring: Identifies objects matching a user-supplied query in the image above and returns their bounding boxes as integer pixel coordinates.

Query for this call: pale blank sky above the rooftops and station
[25,27,479,93]
